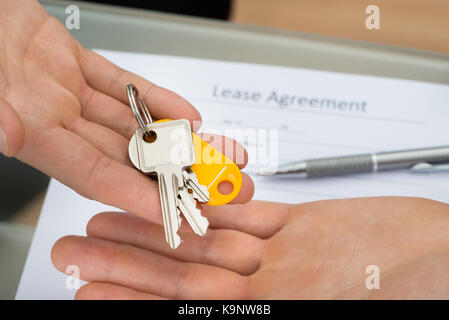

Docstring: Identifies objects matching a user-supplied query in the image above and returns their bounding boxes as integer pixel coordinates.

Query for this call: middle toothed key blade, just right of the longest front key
[178,188,209,236]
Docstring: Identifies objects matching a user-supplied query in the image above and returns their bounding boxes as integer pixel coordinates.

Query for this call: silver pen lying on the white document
[258,146,449,178]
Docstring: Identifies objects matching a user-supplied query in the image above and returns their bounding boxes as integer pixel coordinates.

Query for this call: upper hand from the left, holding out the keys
[0,0,254,223]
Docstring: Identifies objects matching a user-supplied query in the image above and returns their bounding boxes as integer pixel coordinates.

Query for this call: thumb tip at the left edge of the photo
[0,97,25,157]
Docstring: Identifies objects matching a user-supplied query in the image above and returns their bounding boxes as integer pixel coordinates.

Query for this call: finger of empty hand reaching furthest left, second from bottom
[52,236,248,299]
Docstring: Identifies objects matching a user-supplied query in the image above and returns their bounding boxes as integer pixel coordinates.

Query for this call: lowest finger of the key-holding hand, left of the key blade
[22,127,162,223]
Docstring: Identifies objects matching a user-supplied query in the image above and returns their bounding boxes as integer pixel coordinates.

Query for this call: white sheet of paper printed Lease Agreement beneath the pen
[17,51,449,299]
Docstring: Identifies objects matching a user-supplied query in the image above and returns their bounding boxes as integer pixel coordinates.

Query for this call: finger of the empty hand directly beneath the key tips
[86,212,263,275]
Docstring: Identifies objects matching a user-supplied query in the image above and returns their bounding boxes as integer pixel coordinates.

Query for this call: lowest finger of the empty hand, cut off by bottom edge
[75,282,166,300]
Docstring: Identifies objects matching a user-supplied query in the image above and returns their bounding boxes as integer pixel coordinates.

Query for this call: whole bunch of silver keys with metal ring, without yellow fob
[129,84,209,249]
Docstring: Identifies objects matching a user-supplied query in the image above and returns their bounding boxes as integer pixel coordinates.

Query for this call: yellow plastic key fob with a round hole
[156,119,242,206]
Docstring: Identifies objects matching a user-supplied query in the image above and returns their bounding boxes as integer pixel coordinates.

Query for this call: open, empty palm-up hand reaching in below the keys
[52,197,449,299]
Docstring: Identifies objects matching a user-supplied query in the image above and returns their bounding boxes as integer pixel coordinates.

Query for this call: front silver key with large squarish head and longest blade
[129,120,195,249]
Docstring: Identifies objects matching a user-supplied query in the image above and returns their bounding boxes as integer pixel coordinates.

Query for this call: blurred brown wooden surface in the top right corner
[232,0,449,53]
